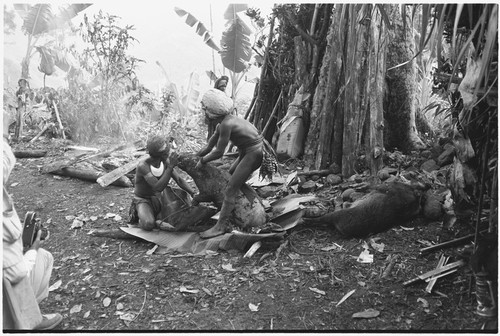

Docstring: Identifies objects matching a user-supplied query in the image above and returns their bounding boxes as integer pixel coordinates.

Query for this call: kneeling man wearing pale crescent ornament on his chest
[131,135,194,231]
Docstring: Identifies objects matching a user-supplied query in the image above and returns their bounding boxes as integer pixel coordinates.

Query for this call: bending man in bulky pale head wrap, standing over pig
[196,91,276,238]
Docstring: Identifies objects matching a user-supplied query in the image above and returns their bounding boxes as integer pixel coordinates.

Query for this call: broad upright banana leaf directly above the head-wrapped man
[221,16,252,73]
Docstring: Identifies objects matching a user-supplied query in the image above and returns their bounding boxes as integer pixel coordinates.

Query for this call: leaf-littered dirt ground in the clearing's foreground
[4,140,496,332]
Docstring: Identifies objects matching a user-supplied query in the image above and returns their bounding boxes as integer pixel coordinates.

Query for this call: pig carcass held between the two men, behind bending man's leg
[177,153,267,230]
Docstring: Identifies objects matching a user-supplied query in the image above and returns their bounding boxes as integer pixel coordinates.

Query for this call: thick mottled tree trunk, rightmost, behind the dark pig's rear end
[385,5,423,152]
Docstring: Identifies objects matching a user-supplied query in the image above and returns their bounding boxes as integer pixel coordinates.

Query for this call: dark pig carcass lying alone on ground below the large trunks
[303,182,422,238]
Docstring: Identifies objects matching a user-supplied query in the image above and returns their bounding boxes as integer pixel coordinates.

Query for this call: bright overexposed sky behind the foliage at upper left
[3,0,273,95]
